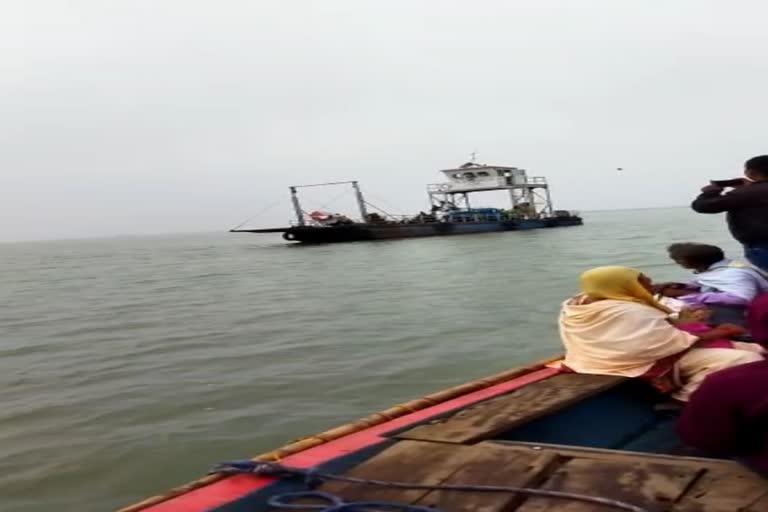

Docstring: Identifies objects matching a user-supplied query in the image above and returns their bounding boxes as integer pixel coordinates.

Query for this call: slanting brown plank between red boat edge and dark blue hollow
[395,373,627,443]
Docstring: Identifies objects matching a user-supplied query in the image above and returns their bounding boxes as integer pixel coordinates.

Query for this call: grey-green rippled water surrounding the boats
[0,209,736,512]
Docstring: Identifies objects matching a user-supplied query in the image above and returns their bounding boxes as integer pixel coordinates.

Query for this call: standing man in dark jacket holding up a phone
[691,155,768,271]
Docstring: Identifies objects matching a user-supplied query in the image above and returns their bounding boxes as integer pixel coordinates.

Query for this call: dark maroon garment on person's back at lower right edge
[677,361,768,472]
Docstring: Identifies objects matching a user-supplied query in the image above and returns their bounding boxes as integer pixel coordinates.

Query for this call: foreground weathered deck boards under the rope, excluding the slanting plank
[286,440,768,512]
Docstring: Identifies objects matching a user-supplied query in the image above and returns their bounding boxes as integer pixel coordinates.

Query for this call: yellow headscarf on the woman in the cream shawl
[580,267,672,313]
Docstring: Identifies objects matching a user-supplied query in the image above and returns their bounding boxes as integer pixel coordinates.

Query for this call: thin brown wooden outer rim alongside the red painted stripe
[117,354,563,512]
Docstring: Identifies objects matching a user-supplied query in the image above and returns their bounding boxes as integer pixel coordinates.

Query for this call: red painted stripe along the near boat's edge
[145,368,559,512]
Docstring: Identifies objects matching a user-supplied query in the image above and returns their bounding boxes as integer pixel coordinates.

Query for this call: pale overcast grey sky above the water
[0,0,768,241]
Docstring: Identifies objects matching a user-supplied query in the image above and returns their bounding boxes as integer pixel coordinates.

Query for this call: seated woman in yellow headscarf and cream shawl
[559,267,762,401]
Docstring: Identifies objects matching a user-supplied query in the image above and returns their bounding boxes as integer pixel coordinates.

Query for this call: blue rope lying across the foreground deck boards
[211,460,649,512]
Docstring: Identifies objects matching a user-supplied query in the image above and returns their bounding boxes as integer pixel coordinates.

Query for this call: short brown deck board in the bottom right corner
[672,467,768,512]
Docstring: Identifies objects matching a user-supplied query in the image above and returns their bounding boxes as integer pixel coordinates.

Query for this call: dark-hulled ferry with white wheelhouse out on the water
[230,162,583,243]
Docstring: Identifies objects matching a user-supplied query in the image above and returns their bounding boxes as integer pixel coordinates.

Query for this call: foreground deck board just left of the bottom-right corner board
[515,459,701,512]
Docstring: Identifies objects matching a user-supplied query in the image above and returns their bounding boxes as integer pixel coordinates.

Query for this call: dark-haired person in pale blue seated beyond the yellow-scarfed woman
[658,243,768,306]
